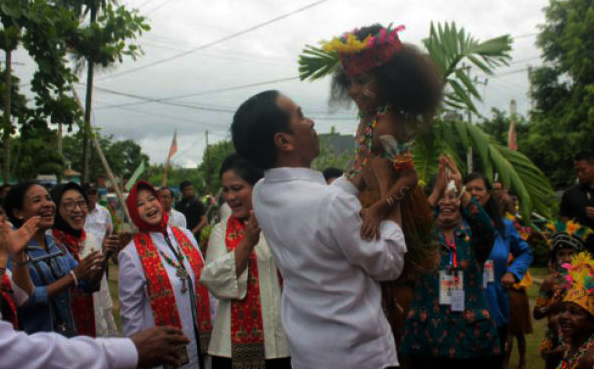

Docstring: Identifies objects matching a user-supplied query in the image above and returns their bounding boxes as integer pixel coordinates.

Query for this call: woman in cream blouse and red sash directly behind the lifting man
[201,154,291,369]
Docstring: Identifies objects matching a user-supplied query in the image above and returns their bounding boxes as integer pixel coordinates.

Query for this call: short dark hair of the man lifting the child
[231,90,291,170]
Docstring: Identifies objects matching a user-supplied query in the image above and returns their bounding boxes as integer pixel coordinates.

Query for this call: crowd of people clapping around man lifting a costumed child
[0,25,594,369]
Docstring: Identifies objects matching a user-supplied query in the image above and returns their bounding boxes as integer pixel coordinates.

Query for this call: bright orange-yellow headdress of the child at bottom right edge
[563,252,594,316]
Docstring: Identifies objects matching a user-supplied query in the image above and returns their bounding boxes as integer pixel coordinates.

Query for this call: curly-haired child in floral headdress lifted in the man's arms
[300,25,443,339]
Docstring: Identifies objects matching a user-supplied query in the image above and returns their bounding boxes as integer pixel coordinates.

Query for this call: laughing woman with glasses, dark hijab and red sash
[51,182,118,337]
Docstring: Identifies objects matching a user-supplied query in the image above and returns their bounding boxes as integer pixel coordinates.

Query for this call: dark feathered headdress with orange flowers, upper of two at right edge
[543,220,594,252]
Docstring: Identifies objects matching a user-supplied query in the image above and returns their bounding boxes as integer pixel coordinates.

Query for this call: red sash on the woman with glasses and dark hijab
[52,228,97,337]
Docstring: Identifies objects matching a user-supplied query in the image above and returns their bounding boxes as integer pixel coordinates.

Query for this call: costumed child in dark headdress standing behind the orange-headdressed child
[533,221,592,369]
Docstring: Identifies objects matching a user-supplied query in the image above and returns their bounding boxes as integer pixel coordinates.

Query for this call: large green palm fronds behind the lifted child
[299,22,553,220]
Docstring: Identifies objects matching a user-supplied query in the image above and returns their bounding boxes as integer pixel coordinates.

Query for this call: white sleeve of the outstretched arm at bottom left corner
[0,321,138,369]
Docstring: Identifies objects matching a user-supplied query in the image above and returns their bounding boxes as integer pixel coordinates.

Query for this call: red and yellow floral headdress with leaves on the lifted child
[299,25,405,80]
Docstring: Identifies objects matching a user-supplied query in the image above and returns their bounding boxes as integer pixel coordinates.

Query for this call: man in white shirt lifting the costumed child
[231,91,406,369]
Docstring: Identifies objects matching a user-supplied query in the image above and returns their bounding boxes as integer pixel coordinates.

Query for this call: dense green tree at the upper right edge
[526,0,594,189]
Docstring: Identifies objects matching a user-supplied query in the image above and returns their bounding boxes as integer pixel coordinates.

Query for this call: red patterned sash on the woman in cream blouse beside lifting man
[225,217,266,369]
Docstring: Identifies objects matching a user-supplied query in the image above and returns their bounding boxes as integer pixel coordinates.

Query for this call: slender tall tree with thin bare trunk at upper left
[59,0,150,181]
